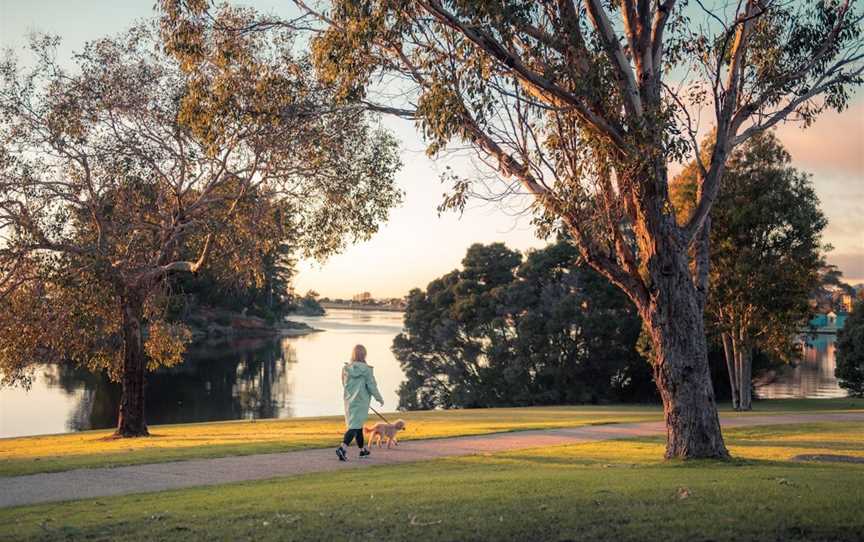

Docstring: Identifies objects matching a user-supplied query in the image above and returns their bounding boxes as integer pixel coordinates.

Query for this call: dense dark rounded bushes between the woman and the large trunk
[393,241,653,409]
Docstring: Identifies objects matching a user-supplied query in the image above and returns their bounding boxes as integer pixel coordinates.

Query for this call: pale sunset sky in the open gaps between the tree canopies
[0,0,864,297]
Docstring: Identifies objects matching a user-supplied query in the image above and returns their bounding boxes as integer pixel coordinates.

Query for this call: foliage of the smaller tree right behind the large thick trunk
[672,132,827,361]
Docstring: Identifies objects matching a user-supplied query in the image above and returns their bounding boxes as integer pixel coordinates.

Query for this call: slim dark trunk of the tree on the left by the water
[114,294,150,437]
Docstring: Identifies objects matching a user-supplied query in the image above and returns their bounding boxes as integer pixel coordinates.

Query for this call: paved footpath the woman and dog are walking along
[0,412,864,508]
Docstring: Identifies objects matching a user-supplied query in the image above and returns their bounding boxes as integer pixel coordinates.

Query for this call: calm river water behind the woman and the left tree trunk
[0,309,403,438]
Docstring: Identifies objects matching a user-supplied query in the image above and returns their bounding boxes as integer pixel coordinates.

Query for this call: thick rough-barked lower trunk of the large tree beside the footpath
[643,237,729,459]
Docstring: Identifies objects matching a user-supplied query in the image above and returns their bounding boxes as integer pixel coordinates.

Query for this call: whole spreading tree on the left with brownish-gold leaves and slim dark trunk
[0,19,399,436]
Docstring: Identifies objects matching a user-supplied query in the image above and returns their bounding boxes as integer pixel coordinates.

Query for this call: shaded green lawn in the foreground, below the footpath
[0,422,864,542]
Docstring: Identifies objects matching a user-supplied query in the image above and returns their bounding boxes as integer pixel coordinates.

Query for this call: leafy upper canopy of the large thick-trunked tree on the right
[302,0,862,236]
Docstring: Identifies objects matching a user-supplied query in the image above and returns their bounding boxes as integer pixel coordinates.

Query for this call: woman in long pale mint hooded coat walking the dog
[336,344,384,461]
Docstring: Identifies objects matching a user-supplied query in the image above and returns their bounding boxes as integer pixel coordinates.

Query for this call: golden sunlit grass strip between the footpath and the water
[0,399,864,476]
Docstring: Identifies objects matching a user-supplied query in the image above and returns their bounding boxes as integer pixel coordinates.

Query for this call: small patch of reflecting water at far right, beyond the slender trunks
[756,333,847,399]
